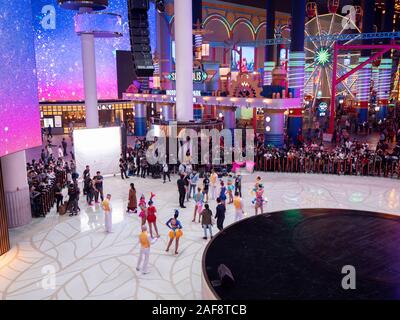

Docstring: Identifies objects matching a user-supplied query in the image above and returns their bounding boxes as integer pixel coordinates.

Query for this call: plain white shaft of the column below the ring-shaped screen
[80,8,99,129]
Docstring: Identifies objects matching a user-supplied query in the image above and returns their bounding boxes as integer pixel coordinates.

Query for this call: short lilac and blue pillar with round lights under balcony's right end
[264,111,285,148]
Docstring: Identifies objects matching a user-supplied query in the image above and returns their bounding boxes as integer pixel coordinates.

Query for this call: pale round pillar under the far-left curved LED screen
[1,151,32,228]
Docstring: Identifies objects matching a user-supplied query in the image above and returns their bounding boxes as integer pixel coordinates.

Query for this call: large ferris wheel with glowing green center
[304,12,361,106]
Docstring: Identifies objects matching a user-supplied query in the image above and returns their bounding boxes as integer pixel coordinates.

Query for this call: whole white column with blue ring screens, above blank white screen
[58,0,122,129]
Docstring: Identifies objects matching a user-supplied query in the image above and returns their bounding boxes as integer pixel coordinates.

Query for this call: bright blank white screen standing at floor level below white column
[73,127,121,176]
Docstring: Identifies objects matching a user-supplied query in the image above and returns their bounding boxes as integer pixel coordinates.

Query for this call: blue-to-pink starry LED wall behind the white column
[32,0,156,101]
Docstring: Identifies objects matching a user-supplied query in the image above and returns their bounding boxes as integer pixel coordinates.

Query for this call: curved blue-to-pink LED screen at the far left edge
[0,0,42,157]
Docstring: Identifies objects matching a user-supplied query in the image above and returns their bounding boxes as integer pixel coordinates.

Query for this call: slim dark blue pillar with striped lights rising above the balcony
[263,1,275,86]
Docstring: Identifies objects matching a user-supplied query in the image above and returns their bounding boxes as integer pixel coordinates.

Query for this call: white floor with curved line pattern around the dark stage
[0,173,400,299]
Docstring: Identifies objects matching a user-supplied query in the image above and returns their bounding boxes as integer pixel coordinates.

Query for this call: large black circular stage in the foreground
[203,209,400,300]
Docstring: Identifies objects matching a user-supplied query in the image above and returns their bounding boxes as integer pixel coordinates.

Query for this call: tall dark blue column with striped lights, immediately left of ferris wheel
[288,0,306,143]
